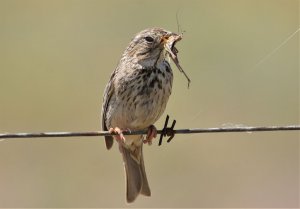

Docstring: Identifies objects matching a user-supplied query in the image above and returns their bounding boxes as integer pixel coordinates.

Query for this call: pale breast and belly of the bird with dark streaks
[116,61,173,130]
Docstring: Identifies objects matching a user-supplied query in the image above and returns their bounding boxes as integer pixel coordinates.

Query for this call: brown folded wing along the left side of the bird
[101,71,115,149]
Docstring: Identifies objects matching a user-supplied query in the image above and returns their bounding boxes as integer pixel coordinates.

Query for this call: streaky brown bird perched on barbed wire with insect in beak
[101,27,182,203]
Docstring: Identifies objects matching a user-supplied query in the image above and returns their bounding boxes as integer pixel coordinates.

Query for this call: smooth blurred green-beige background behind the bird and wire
[0,0,300,208]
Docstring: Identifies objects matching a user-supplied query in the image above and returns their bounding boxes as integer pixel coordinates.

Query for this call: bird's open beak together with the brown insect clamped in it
[162,34,191,87]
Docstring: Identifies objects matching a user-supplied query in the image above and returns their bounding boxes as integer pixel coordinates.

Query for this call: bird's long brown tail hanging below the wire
[120,145,151,203]
